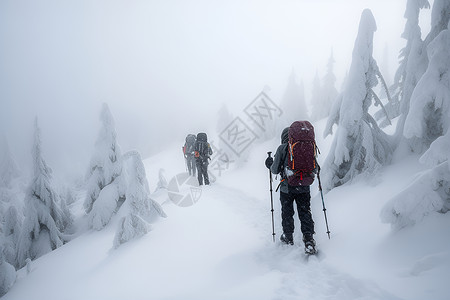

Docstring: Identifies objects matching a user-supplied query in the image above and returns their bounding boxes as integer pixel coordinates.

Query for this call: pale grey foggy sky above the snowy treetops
[0,0,429,179]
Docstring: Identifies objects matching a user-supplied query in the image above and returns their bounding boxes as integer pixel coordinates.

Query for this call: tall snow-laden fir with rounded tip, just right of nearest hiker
[323,9,392,190]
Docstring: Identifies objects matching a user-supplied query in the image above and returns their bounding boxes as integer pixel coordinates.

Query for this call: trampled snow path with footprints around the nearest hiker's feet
[200,186,399,299]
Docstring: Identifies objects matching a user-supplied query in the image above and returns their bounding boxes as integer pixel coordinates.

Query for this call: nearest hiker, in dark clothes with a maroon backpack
[265,121,318,254]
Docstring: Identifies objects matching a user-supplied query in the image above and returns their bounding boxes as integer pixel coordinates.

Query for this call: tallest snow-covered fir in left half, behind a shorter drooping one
[84,103,125,230]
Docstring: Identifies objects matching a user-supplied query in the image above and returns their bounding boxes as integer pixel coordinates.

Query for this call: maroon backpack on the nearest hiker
[285,121,317,186]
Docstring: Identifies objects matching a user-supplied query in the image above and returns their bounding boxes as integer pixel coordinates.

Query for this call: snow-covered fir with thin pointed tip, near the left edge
[16,119,70,267]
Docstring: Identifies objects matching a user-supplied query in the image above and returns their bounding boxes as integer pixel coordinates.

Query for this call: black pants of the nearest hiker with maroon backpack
[280,192,314,235]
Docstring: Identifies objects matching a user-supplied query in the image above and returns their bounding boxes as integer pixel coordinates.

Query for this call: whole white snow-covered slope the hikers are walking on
[2,122,450,300]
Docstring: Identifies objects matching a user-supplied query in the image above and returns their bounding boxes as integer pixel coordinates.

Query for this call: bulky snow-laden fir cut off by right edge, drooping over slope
[382,22,450,228]
